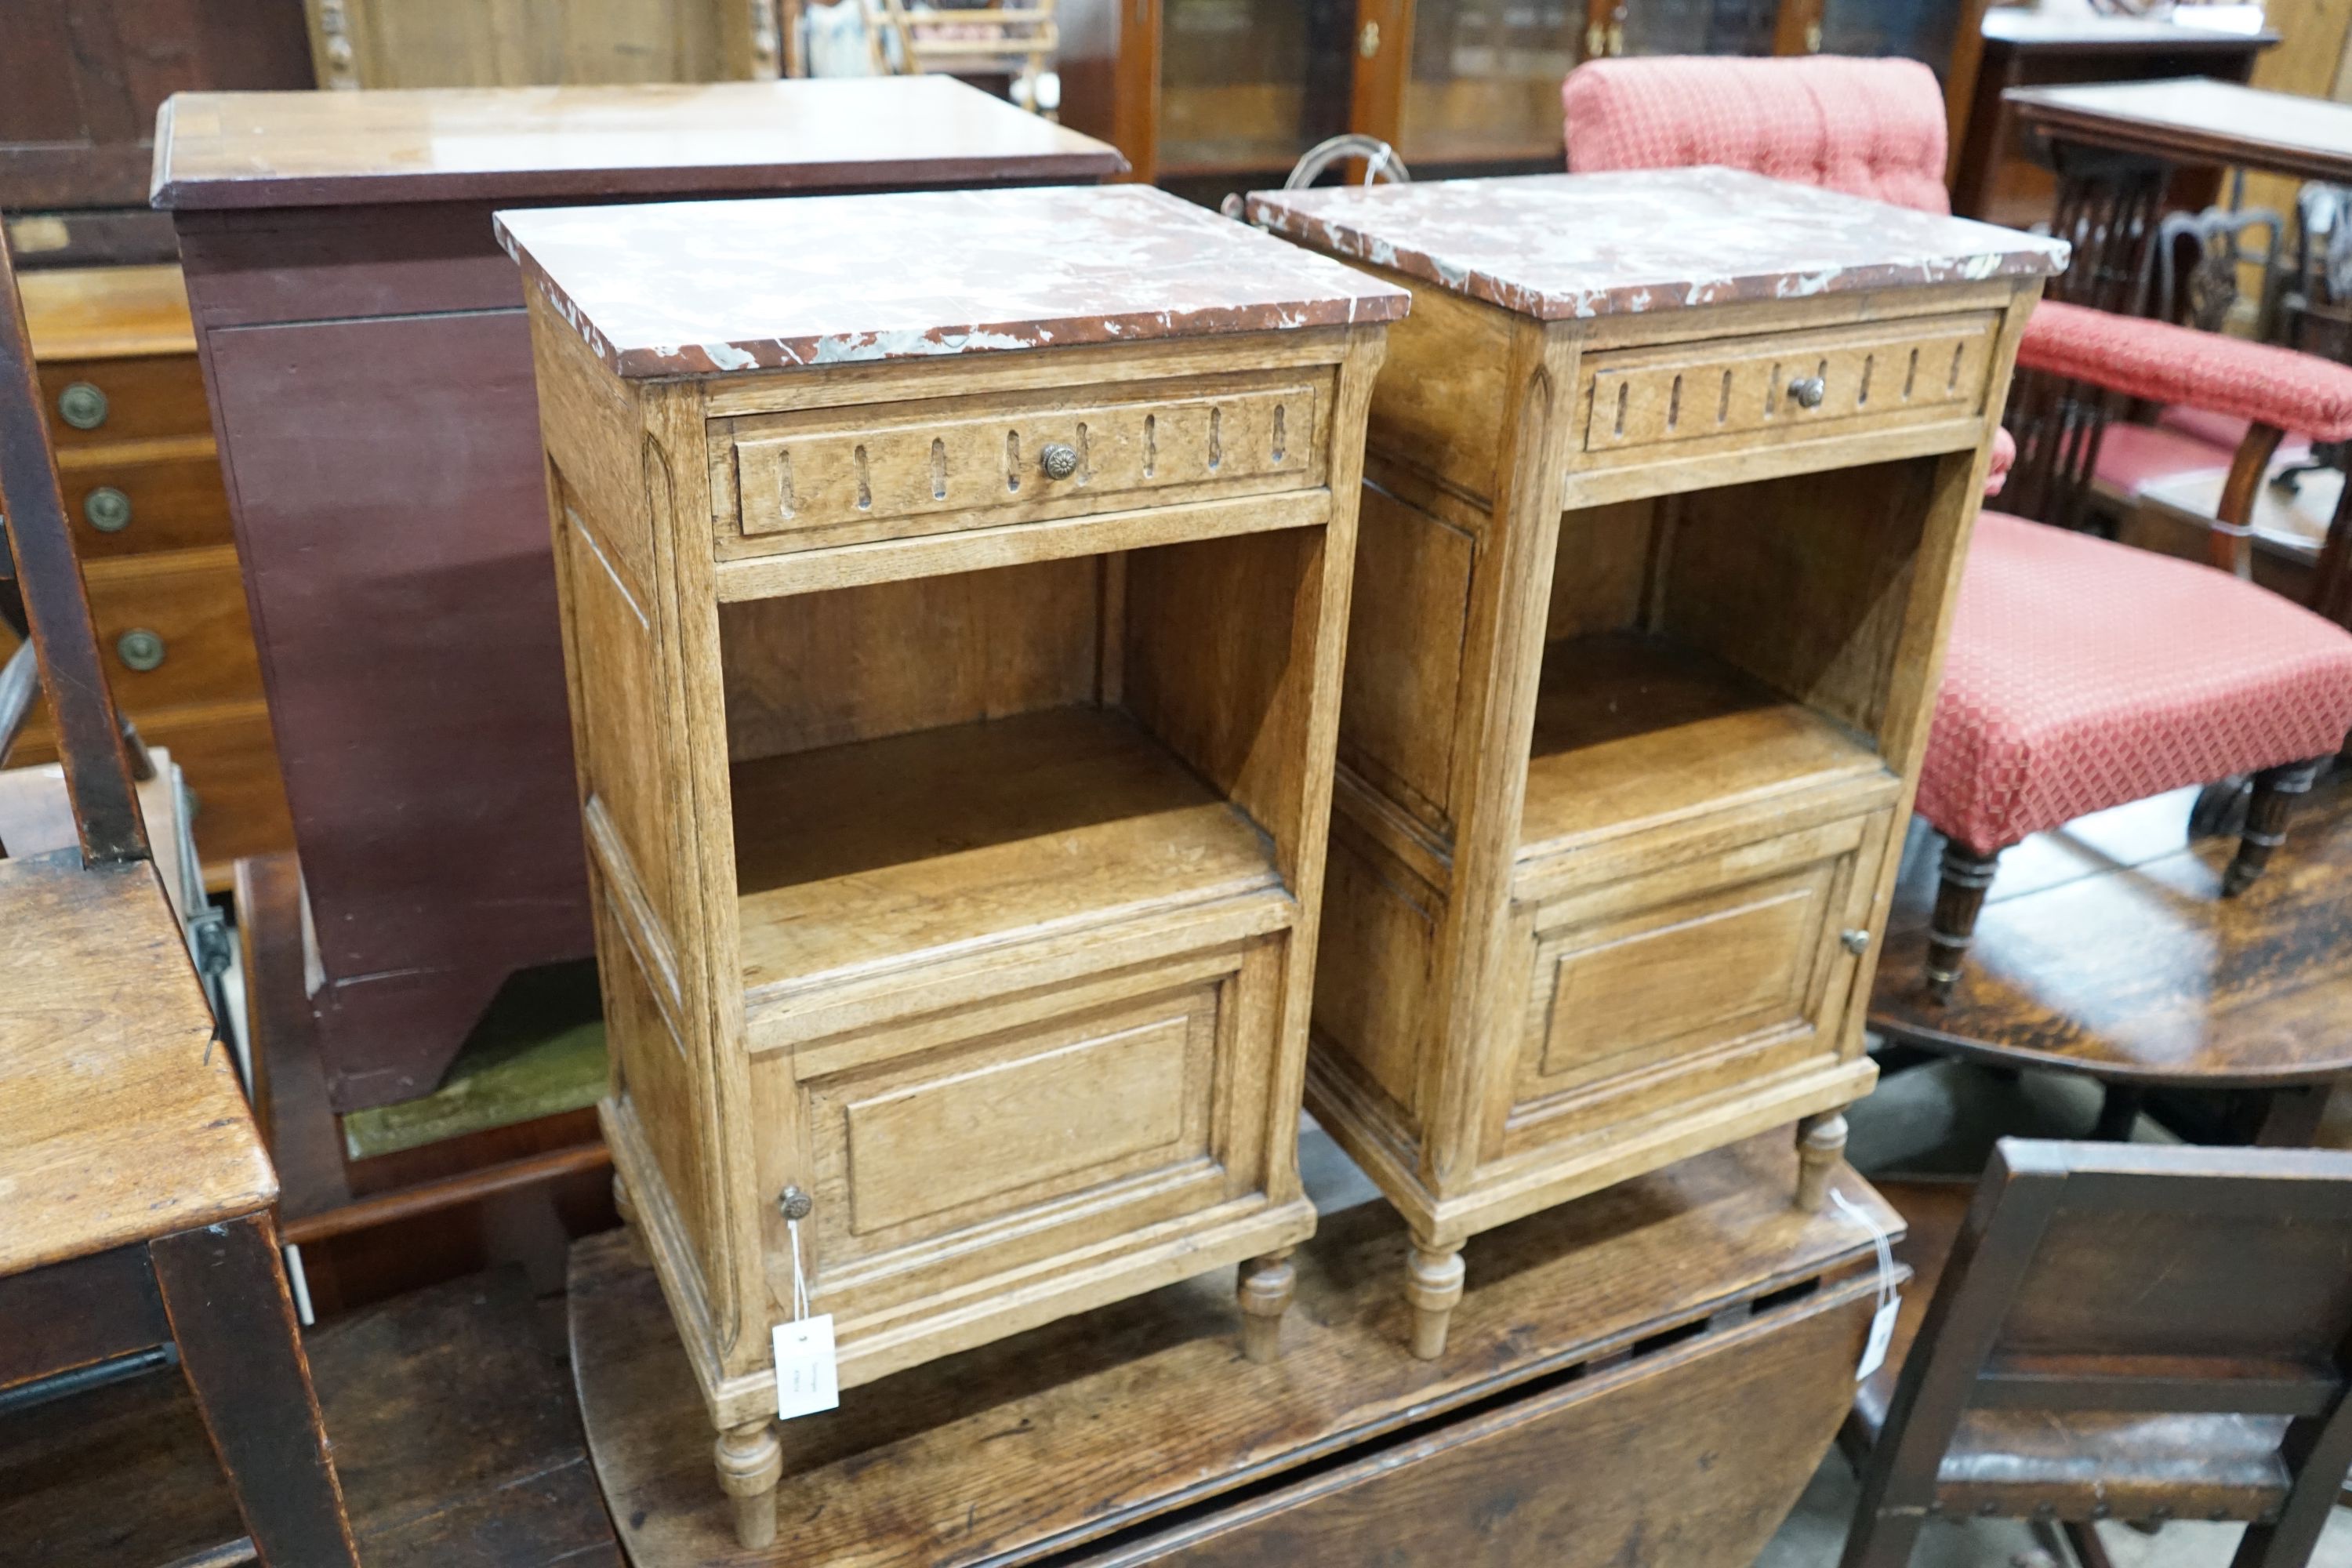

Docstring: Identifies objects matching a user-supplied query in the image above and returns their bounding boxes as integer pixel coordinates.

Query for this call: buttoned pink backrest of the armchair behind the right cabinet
[1559,54,1952,212]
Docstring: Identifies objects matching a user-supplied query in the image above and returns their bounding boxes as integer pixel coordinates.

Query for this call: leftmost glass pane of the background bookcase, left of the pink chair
[1160,0,1355,176]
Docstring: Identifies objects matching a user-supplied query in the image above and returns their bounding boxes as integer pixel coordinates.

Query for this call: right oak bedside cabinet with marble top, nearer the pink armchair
[1249,169,2065,1356]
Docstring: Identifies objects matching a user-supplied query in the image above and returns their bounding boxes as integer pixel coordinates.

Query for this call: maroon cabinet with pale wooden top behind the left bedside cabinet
[155,78,1124,1109]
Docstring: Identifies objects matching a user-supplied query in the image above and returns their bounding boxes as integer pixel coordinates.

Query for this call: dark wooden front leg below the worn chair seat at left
[148,1213,360,1568]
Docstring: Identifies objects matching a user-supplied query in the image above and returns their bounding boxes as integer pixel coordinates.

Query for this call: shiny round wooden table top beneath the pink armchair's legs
[1870,771,2352,1086]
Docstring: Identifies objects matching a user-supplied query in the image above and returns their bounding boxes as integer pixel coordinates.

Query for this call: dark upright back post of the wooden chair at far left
[0,238,148,865]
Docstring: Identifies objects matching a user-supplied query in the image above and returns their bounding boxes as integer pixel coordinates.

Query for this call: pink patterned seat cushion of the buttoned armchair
[1919,513,2352,853]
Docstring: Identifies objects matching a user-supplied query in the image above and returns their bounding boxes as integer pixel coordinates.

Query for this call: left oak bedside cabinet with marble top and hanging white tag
[499,186,1406,1542]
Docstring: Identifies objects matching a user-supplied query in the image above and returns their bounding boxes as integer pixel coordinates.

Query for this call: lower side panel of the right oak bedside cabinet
[1315,829,1437,1131]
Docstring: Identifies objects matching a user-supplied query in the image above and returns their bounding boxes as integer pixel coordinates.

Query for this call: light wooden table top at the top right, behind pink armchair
[2002,78,2352,181]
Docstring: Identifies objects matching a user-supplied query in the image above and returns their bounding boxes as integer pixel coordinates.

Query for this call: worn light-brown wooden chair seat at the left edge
[0,848,278,1276]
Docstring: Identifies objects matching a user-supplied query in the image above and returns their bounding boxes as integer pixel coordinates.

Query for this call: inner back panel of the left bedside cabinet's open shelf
[720,557,1101,762]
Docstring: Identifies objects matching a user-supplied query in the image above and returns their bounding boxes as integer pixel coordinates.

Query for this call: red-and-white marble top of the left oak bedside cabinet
[496,186,1411,376]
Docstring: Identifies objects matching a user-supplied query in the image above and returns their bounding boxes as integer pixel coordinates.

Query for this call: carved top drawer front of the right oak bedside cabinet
[1581,310,2002,466]
